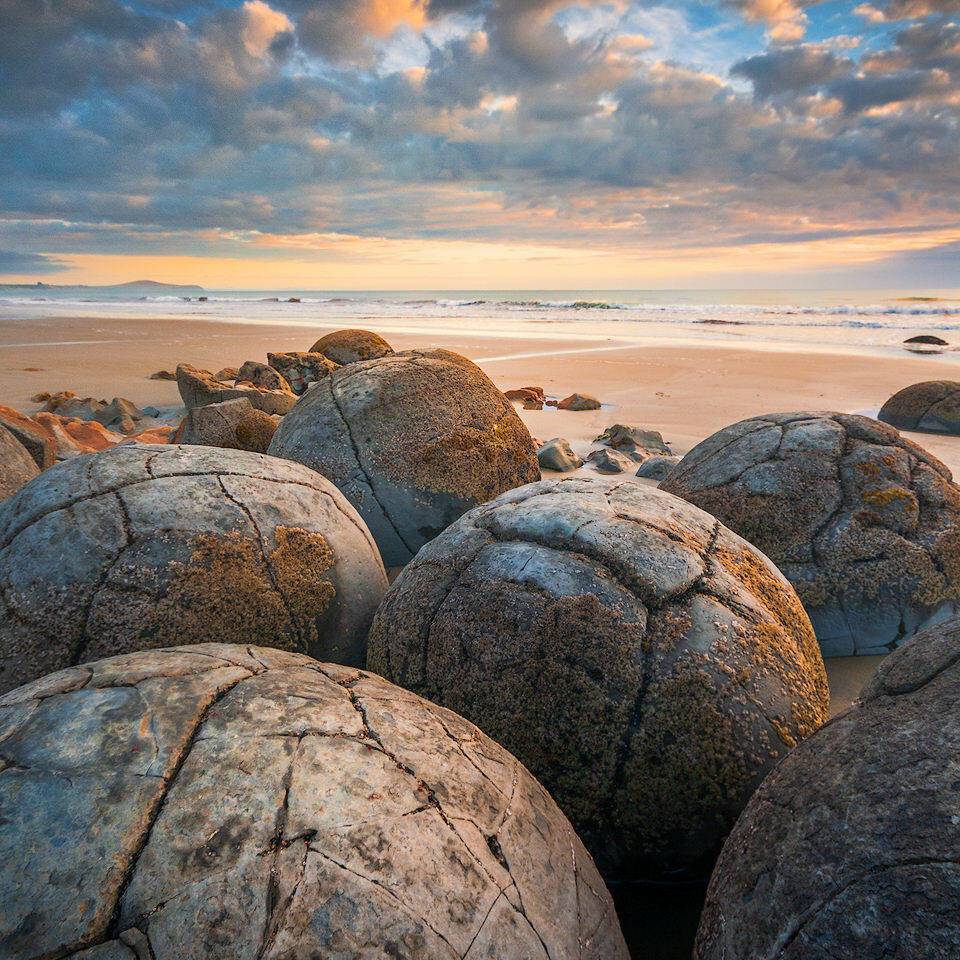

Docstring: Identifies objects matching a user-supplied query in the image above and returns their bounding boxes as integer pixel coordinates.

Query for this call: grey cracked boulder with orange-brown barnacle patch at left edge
[0,445,387,692]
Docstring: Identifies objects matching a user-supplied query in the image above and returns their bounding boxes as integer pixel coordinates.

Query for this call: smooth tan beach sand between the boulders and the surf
[0,317,960,712]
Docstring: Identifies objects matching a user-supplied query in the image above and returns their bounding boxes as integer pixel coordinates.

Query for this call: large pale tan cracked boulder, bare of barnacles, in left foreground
[0,644,628,960]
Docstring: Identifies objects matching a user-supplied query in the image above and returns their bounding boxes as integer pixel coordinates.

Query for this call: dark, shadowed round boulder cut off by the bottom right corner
[694,620,960,960]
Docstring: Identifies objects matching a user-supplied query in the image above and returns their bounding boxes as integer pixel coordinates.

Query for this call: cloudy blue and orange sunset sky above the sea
[0,0,960,290]
